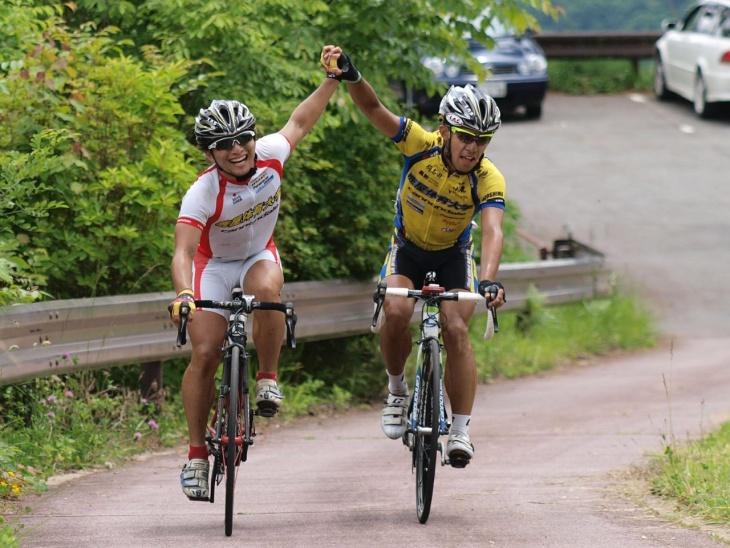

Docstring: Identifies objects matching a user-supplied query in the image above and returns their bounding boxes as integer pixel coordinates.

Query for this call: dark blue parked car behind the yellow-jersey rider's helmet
[412,26,548,118]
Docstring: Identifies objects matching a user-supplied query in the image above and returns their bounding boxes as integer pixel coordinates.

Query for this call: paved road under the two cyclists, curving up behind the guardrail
[12,95,730,548]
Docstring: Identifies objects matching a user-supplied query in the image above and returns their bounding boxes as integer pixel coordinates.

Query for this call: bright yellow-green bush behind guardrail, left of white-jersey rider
[0,7,195,298]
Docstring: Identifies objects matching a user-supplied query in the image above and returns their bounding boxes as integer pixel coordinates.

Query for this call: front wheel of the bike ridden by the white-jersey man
[225,345,242,537]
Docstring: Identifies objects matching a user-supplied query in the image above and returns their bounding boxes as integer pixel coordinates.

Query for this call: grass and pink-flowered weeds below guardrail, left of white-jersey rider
[0,371,184,480]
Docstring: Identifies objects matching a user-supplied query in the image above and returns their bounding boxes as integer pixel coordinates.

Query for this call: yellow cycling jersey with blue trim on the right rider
[393,117,505,251]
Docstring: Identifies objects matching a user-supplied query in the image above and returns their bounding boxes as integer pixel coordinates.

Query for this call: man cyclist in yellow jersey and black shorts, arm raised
[322,46,505,466]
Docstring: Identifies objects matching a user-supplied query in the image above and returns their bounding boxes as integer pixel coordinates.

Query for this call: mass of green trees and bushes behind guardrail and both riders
[0,0,555,298]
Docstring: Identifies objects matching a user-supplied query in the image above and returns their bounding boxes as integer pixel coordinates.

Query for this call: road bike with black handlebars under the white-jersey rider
[177,287,297,536]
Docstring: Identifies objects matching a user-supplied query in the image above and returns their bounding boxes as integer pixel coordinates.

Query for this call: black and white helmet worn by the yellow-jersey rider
[439,84,502,133]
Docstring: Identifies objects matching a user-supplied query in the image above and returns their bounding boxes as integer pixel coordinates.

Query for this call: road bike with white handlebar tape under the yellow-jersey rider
[371,272,499,523]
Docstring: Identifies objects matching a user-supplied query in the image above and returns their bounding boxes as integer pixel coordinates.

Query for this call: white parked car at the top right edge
[654,0,730,118]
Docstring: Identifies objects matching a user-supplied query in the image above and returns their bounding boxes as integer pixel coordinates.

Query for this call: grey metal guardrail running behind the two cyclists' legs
[0,253,610,385]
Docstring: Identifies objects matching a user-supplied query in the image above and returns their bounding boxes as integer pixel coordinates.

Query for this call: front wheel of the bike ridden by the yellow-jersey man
[415,339,441,523]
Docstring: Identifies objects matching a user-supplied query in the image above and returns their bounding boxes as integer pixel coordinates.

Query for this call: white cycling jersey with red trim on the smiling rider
[177,133,291,261]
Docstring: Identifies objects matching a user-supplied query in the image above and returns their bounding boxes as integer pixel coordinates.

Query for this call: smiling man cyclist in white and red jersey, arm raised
[169,50,339,500]
